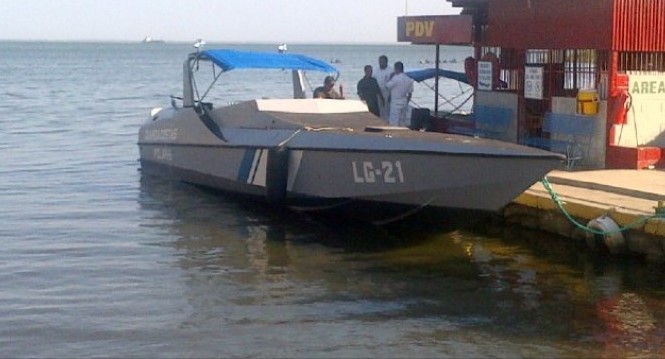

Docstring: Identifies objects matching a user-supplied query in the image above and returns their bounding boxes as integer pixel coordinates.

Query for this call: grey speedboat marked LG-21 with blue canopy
[138,49,563,224]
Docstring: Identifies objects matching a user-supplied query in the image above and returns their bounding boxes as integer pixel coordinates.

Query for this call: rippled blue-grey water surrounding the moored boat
[0,42,665,358]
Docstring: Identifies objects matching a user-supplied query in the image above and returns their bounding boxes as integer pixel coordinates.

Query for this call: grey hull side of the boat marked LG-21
[140,144,557,222]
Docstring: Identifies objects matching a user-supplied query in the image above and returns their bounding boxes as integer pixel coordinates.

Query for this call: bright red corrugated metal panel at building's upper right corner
[612,0,665,51]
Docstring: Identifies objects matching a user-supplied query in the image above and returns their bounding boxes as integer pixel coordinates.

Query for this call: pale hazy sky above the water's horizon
[0,0,459,43]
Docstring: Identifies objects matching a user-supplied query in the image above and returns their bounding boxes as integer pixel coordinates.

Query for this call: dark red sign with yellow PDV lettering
[397,15,472,45]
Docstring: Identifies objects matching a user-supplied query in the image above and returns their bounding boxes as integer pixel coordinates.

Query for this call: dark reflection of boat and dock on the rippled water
[140,177,665,357]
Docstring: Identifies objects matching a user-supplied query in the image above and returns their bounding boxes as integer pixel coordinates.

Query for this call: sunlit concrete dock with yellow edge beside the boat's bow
[502,169,665,260]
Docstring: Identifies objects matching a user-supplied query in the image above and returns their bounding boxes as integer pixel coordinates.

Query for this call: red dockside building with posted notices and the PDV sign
[398,0,665,169]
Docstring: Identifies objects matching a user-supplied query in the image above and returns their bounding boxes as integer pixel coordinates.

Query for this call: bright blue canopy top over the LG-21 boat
[199,49,337,74]
